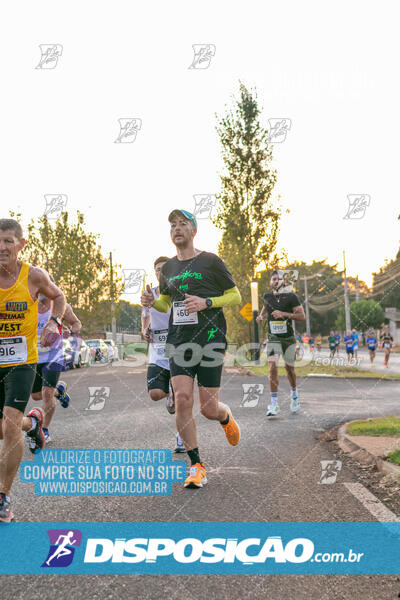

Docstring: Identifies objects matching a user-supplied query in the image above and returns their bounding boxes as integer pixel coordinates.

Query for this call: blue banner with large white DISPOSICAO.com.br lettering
[0,522,400,575]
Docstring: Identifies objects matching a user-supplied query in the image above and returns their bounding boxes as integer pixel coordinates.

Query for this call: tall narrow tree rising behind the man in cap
[213,83,281,343]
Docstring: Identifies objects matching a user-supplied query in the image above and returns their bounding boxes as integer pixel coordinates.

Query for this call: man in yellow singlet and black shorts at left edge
[0,219,65,522]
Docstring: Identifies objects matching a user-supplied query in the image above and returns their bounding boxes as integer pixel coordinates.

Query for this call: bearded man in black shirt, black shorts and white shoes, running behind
[257,271,305,417]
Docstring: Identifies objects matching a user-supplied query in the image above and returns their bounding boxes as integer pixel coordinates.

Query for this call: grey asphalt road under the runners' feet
[0,363,400,600]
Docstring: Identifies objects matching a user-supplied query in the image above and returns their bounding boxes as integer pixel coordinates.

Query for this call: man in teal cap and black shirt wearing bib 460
[141,210,241,488]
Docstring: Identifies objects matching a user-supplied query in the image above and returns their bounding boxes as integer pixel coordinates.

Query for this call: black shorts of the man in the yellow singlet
[0,364,36,419]
